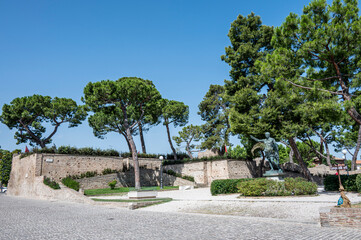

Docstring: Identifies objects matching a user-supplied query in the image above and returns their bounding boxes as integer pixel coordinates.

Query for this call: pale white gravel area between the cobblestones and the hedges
[91,188,361,224]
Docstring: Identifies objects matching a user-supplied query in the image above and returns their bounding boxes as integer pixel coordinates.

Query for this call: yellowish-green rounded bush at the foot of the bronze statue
[238,178,317,196]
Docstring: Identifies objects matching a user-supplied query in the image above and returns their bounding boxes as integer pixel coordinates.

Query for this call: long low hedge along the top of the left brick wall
[21,146,119,158]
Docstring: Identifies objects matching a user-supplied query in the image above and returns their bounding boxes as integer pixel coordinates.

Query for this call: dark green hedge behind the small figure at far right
[323,174,357,192]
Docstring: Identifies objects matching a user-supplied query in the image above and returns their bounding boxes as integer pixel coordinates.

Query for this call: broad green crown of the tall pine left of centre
[82,77,161,145]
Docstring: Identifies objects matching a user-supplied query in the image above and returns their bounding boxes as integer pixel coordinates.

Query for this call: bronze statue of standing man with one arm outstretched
[251,132,282,172]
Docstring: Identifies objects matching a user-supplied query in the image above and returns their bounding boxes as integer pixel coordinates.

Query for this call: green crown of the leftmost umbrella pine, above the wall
[0,95,87,148]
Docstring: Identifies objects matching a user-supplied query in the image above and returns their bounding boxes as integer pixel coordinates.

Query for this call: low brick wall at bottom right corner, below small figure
[320,207,361,229]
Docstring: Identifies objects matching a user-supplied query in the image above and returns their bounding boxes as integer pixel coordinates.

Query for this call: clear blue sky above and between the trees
[0,0,344,156]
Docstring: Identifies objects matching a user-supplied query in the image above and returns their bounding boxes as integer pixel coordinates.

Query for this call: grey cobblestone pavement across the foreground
[0,194,361,240]
